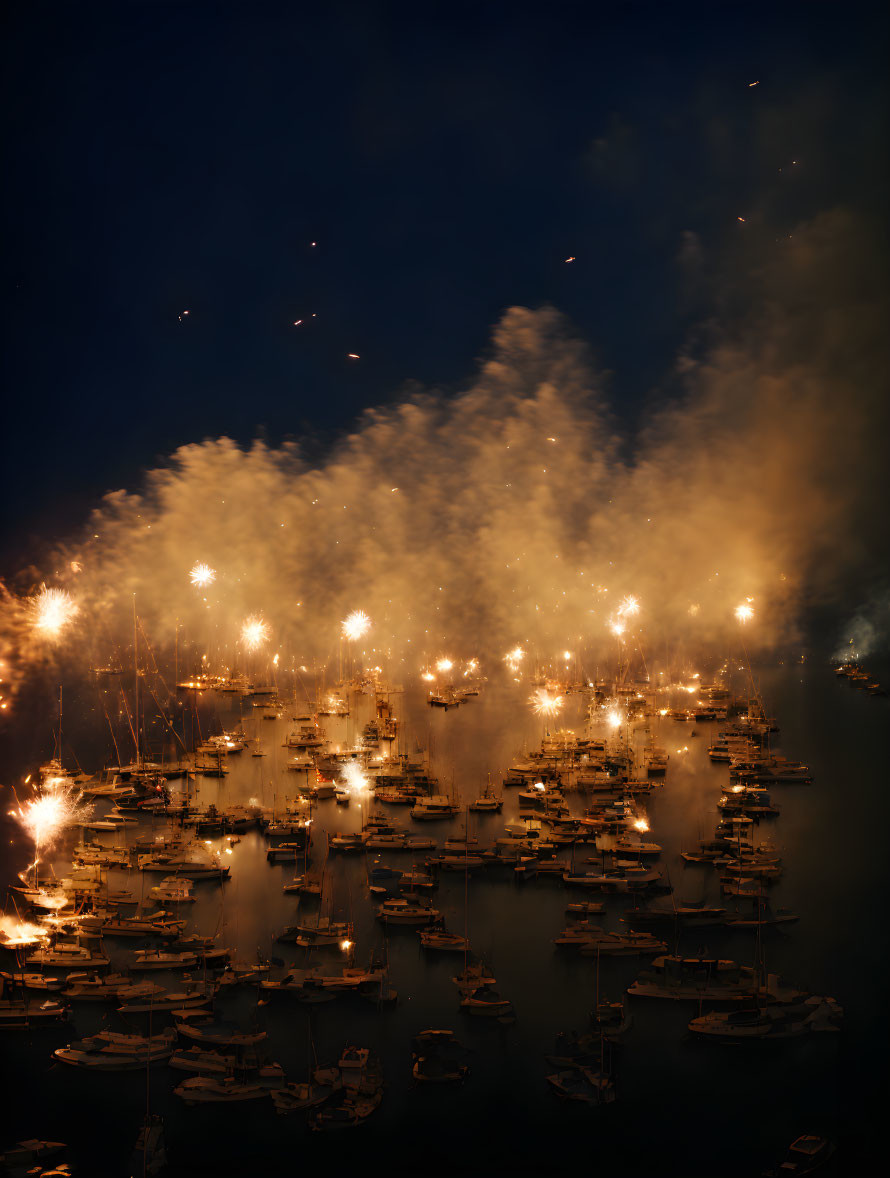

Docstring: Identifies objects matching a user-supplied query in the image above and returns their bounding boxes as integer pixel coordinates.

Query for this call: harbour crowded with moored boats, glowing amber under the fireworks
[0,667,881,1174]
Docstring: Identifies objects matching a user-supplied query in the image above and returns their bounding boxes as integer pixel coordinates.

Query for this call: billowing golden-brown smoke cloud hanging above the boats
[2,211,889,692]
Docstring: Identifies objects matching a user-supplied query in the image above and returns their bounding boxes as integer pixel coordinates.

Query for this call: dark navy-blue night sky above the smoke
[0,2,888,569]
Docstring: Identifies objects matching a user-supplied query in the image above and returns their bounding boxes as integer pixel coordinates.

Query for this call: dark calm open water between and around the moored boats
[0,666,890,1178]
